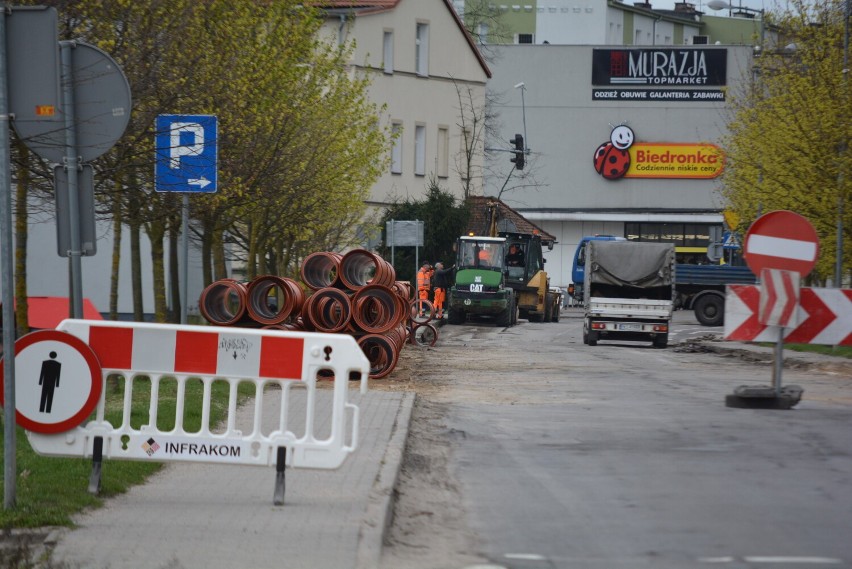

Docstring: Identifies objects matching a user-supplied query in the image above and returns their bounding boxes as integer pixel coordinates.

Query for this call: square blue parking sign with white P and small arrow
[154,115,217,193]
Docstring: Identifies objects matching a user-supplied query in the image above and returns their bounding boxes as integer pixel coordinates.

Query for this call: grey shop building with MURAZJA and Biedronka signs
[485,44,753,287]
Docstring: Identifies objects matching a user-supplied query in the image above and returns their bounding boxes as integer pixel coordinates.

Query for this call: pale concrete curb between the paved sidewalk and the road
[355,391,416,569]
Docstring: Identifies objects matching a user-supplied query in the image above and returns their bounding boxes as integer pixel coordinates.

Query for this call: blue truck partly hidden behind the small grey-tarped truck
[569,235,757,326]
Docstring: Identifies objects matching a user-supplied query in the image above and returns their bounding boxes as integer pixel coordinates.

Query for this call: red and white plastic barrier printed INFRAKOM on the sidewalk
[27,319,370,504]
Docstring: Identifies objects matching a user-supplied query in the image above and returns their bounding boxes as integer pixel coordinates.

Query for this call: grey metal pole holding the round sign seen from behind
[59,41,83,318]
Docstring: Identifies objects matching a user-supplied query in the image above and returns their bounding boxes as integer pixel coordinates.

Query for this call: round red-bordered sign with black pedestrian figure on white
[0,330,103,434]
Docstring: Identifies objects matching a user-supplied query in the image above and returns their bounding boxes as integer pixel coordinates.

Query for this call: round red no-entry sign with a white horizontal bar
[743,210,819,277]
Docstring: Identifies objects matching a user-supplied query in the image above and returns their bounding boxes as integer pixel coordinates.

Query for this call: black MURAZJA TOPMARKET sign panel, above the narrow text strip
[592,48,728,87]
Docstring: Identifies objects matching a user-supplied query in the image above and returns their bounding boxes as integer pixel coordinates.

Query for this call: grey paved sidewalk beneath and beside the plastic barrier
[46,389,414,569]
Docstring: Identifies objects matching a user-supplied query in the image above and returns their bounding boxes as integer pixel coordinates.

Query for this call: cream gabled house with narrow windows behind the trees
[324,0,491,206]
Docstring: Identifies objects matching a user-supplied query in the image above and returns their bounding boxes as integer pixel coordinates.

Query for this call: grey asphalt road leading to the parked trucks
[384,309,852,569]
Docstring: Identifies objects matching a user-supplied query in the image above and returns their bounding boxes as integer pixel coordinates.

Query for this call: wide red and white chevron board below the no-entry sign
[725,285,852,346]
